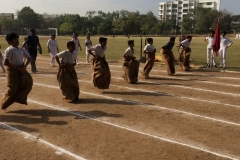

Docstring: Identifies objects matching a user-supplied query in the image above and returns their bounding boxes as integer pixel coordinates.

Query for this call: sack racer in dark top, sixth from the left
[160,37,176,75]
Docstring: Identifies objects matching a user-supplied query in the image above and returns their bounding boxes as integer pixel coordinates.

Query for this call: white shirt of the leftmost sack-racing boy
[4,46,31,66]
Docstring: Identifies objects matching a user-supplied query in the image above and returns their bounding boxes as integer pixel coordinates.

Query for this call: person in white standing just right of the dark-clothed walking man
[47,34,59,67]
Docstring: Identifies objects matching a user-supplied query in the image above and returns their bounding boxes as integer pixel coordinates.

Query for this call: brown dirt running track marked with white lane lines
[0,56,240,160]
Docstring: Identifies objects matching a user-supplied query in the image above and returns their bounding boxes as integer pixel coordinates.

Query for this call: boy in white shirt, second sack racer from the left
[55,41,79,103]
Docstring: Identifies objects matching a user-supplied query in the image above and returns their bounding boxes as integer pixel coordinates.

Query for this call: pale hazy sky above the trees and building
[0,0,240,16]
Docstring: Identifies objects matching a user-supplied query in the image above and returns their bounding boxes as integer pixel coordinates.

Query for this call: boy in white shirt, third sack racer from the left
[88,37,111,89]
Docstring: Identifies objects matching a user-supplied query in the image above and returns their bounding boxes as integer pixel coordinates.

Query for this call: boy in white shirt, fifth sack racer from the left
[142,38,156,79]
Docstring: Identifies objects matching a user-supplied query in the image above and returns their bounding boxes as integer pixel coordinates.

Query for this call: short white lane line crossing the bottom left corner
[0,122,85,160]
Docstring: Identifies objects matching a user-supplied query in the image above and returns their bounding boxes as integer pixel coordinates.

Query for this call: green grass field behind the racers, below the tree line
[0,36,240,70]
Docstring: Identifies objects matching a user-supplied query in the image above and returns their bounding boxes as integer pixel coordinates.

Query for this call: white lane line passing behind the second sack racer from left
[34,82,240,127]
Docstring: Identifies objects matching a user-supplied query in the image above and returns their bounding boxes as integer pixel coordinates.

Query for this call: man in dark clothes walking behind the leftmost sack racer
[22,29,42,73]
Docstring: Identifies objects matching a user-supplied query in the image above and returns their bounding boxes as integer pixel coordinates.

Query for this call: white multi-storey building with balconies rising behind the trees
[159,0,221,22]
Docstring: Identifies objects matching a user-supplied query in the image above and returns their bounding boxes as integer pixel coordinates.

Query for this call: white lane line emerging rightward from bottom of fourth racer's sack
[111,77,240,97]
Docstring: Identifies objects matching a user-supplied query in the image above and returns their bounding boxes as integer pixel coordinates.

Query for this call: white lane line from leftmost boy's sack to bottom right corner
[29,99,240,160]
